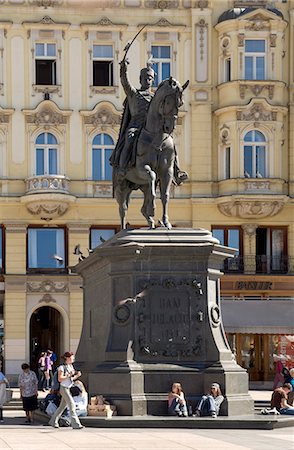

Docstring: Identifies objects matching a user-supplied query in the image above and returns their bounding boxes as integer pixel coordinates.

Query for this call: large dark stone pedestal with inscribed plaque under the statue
[75,228,253,415]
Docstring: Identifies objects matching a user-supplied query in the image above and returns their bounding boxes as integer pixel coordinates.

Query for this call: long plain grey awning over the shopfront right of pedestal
[221,299,294,335]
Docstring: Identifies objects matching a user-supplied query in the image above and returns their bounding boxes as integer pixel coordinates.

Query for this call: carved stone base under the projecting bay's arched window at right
[218,200,284,219]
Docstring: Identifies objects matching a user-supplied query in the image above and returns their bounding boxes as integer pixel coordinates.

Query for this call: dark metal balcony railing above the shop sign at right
[223,255,294,275]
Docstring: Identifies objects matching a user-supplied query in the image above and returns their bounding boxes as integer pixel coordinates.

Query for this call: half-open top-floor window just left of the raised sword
[93,45,113,86]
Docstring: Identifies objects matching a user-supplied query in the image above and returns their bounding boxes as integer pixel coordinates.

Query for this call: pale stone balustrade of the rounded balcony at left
[26,175,69,194]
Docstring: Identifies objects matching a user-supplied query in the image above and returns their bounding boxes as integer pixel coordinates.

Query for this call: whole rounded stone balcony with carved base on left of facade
[21,175,76,220]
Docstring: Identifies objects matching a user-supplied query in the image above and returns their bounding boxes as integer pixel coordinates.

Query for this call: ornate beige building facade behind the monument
[0,0,294,382]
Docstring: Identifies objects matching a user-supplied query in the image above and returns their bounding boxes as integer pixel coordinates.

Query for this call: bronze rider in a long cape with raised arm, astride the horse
[110,58,188,185]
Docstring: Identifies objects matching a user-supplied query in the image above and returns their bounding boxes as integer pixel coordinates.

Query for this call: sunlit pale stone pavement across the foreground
[0,391,294,450]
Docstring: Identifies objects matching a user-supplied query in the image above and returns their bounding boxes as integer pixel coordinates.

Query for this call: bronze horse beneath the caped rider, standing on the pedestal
[113,77,189,229]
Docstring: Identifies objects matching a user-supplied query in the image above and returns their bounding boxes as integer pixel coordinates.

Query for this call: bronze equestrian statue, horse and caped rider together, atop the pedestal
[110,41,189,229]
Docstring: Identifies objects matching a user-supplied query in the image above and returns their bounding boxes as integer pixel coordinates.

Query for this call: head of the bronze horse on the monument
[156,77,189,134]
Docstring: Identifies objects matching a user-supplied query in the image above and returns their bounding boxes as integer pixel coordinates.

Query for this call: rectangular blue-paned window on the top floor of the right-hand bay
[244,39,265,80]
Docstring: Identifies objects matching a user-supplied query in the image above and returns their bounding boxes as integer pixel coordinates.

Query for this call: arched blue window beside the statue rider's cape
[92,133,114,181]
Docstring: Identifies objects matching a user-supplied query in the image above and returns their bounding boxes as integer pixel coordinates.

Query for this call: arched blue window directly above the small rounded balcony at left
[36,133,58,175]
